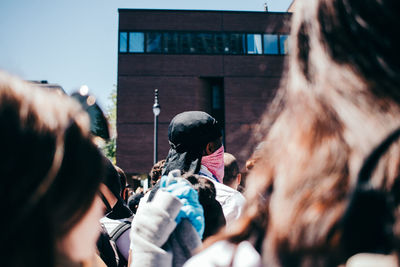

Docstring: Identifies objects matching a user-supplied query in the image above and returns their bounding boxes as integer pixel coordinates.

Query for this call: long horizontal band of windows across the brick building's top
[119,31,289,55]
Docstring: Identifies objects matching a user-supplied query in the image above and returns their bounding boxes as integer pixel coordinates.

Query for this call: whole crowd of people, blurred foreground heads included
[0,0,400,267]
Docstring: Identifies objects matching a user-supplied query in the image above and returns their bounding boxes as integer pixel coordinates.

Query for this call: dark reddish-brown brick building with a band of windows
[117,9,290,174]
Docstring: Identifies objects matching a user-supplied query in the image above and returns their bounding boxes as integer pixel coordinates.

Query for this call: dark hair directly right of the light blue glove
[183,174,226,240]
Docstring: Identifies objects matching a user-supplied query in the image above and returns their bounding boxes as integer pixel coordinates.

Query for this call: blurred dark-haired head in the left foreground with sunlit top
[0,73,103,267]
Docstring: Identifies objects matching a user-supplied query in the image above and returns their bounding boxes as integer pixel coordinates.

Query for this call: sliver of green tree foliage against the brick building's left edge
[101,85,117,164]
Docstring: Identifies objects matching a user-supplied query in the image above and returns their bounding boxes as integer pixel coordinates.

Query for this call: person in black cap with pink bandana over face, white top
[162,111,245,225]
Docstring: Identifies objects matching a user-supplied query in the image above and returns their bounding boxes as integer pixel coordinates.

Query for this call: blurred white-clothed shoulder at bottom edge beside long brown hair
[184,241,261,267]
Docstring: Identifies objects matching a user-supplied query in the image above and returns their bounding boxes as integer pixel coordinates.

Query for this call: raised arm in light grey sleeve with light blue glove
[130,177,204,267]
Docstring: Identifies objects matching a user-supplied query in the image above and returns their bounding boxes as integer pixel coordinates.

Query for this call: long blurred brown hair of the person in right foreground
[212,0,400,266]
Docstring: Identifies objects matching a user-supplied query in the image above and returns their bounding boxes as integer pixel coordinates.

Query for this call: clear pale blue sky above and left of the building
[0,0,292,107]
